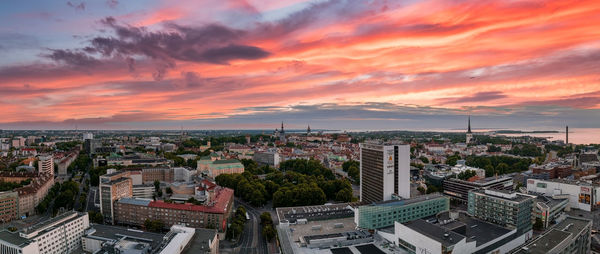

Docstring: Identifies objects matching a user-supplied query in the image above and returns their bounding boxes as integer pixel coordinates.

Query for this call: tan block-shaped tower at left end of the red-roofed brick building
[98,171,133,223]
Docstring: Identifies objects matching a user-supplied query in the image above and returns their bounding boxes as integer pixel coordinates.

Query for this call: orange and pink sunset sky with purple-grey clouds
[0,0,600,130]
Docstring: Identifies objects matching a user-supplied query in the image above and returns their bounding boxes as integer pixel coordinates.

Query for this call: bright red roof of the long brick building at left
[148,188,233,213]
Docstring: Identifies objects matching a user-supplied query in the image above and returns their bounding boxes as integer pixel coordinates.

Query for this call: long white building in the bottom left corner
[0,211,90,254]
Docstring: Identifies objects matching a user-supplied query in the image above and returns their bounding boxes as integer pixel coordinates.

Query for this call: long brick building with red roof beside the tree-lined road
[115,187,233,232]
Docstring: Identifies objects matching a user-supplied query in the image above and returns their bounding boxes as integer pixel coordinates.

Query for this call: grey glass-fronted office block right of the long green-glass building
[467,189,534,234]
